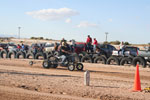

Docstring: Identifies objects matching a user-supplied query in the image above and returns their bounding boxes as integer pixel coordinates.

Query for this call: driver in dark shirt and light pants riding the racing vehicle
[60,42,71,64]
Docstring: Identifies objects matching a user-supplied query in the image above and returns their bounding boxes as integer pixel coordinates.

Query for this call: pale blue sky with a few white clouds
[0,0,150,44]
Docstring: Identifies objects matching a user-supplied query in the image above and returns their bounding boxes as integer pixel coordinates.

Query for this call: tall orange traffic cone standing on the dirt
[133,64,141,92]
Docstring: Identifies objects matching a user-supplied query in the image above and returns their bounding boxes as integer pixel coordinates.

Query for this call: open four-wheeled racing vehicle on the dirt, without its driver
[42,54,83,71]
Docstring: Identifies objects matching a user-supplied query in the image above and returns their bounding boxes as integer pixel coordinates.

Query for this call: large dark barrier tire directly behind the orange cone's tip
[132,57,146,68]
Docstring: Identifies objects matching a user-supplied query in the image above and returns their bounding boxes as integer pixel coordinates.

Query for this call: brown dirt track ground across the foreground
[0,59,150,100]
